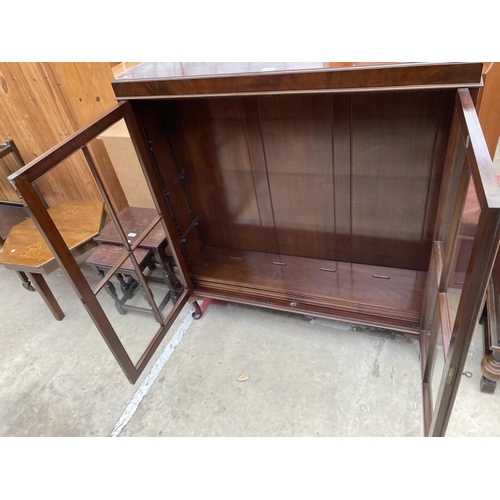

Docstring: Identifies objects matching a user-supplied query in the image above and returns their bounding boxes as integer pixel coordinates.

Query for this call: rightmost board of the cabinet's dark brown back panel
[351,92,446,269]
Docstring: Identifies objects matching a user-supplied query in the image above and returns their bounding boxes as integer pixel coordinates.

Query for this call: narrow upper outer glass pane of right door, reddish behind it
[448,177,481,324]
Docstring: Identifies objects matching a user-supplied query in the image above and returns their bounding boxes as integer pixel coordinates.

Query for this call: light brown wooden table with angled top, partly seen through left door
[0,202,105,321]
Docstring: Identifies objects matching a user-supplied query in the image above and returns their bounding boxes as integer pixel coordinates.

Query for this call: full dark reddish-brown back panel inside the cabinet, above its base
[144,90,454,270]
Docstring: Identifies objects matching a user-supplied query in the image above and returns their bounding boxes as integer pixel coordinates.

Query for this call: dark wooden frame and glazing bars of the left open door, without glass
[8,102,191,384]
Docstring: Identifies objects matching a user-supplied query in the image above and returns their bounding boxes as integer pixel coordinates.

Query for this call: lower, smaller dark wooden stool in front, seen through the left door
[86,243,172,322]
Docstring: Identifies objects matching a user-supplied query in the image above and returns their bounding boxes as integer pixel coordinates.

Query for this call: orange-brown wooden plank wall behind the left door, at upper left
[0,63,127,209]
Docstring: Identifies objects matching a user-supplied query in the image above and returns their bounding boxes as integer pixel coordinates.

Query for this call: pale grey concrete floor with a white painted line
[0,139,500,436]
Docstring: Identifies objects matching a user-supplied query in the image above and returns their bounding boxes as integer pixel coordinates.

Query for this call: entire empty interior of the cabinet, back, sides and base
[132,89,455,332]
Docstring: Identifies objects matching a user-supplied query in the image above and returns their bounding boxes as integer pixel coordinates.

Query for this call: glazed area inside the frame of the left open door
[24,117,184,363]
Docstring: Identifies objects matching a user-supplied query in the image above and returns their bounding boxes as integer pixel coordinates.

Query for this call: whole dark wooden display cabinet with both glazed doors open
[10,63,500,436]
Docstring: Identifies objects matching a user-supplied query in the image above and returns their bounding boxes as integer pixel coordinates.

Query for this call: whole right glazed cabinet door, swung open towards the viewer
[421,89,500,436]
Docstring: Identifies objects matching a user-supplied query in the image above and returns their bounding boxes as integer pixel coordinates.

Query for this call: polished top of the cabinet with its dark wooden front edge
[113,63,482,99]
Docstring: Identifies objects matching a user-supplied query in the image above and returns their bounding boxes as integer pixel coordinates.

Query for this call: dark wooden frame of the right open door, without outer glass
[421,89,500,436]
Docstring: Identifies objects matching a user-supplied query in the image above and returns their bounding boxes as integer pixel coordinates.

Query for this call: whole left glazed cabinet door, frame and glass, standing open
[9,102,190,384]
